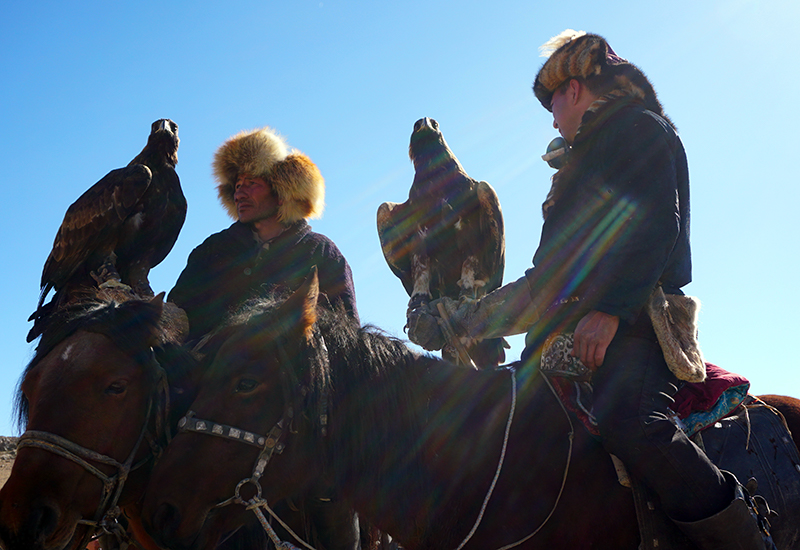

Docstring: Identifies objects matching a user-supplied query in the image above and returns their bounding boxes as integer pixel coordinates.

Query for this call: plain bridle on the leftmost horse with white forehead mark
[17,348,171,548]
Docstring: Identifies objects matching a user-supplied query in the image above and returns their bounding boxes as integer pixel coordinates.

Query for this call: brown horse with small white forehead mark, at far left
[0,290,197,550]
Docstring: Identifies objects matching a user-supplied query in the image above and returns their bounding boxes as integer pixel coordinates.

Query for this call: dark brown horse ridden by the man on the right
[142,273,800,550]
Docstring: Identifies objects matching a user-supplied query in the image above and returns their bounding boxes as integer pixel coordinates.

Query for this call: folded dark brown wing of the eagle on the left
[39,164,152,306]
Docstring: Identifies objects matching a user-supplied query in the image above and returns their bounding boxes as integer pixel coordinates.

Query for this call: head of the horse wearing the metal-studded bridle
[142,269,327,550]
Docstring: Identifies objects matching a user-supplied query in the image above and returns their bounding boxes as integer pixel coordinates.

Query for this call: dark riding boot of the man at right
[673,470,776,550]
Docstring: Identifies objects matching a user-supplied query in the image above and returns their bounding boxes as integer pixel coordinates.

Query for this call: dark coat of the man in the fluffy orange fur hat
[168,220,358,341]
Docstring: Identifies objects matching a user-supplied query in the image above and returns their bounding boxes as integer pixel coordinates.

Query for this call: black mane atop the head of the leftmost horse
[14,291,190,429]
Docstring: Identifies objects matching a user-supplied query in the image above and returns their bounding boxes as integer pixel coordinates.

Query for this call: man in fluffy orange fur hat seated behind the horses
[169,127,359,550]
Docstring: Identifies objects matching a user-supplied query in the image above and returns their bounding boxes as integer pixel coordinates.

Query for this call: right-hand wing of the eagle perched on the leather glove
[475,181,506,292]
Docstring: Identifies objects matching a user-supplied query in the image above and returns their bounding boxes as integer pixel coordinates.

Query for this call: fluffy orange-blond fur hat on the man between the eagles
[212,126,325,224]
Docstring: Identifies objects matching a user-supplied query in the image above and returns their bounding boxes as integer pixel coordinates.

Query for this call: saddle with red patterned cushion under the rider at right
[540,344,800,550]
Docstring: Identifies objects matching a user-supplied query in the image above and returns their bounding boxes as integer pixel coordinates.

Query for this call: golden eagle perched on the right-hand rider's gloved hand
[378,117,505,367]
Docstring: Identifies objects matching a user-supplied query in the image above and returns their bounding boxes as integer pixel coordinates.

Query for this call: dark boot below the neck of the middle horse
[305,497,360,550]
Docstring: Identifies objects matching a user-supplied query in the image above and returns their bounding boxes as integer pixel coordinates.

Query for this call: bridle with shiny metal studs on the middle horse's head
[178,333,328,550]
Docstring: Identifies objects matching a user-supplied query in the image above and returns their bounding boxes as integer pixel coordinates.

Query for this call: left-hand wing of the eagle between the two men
[378,201,418,296]
